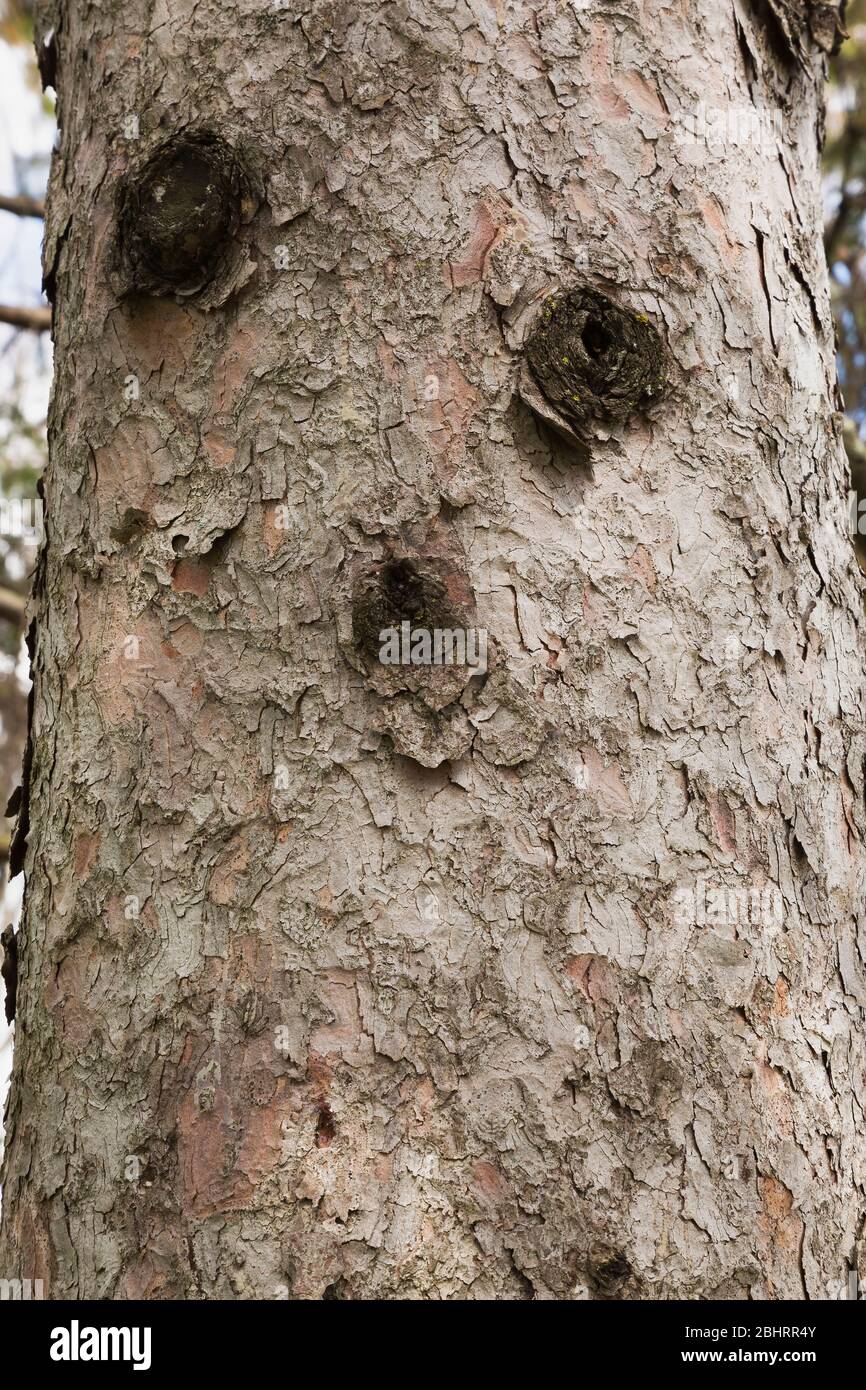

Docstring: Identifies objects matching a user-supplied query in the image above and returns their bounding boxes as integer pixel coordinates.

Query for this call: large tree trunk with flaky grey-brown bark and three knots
[0,0,866,1300]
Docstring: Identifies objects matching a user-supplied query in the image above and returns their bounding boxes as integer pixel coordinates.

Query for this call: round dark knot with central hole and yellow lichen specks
[525,286,667,430]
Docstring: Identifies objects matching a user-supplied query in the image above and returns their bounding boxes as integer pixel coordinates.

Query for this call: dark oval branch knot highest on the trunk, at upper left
[121,132,245,295]
